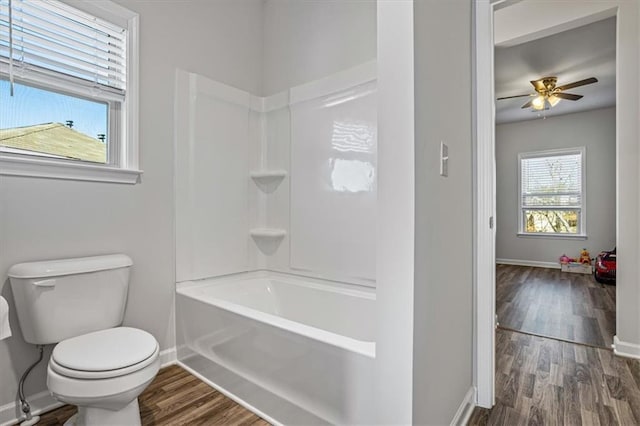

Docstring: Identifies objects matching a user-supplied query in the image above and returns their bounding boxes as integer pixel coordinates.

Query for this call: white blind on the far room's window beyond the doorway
[520,152,582,209]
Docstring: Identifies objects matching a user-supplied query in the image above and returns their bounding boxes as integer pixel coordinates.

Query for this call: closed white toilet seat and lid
[49,327,159,379]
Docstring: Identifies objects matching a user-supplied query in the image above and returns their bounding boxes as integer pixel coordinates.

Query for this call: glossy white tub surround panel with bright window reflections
[290,76,377,282]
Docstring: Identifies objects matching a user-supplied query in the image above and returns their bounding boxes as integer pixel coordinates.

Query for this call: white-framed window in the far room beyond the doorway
[518,147,586,237]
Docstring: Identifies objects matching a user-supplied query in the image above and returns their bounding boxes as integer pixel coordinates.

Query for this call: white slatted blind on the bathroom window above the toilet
[0,0,127,99]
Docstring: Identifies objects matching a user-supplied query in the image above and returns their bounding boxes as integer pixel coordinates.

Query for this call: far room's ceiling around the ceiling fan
[495,18,616,123]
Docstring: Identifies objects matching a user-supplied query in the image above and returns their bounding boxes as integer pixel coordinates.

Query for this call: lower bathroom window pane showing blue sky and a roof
[0,80,109,164]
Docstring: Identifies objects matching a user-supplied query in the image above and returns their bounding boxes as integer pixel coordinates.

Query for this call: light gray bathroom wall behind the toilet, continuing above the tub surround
[0,0,262,412]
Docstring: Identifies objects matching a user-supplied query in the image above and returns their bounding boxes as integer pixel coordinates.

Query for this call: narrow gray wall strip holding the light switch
[413,0,473,425]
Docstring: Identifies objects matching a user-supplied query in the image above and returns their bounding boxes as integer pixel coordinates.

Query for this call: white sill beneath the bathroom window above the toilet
[0,155,142,185]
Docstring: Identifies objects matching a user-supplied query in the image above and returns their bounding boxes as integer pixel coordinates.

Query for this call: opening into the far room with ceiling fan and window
[494,17,616,349]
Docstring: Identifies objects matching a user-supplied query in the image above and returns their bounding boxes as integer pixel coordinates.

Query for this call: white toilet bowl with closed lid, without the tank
[47,327,160,426]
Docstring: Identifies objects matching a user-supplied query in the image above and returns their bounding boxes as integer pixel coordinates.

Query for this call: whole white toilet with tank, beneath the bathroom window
[8,254,160,426]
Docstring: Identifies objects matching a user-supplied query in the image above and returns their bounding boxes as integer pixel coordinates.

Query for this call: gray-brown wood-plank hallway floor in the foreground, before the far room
[468,329,640,426]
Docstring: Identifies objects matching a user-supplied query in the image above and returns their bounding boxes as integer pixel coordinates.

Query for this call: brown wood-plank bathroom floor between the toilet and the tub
[33,365,269,426]
